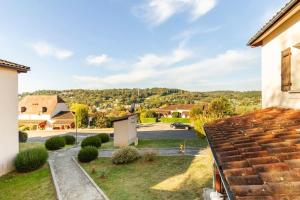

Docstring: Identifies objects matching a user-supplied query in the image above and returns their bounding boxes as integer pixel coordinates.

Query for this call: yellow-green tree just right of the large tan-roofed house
[71,103,89,128]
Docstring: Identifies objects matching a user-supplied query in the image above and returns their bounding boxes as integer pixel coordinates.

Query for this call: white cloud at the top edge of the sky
[133,0,217,26]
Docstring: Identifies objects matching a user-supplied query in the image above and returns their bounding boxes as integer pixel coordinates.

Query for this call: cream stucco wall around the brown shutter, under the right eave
[262,13,300,109]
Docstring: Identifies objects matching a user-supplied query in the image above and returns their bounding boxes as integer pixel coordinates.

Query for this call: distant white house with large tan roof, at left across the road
[19,95,74,130]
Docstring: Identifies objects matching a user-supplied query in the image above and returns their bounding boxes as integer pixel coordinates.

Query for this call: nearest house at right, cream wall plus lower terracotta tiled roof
[205,0,300,200]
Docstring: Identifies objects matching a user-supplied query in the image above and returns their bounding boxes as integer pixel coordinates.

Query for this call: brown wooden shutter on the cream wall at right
[281,48,292,92]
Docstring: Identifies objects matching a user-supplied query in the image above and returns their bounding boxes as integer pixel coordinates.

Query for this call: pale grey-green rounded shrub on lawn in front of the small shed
[112,146,141,165]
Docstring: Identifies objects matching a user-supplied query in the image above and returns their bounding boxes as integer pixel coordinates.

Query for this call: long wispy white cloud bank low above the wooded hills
[73,49,259,90]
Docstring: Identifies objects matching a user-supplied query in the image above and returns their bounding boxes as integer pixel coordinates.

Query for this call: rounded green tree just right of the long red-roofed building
[208,97,234,117]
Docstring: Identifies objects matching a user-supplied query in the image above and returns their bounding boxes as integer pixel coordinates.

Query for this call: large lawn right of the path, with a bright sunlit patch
[82,149,212,200]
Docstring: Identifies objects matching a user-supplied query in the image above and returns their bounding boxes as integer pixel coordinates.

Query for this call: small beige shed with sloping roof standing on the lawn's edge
[113,114,138,147]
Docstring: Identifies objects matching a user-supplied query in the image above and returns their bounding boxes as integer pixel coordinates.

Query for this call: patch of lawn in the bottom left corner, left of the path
[0,165,56,200]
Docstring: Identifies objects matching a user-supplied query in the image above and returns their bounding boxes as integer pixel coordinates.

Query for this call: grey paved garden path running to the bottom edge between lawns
[49,148,106,200]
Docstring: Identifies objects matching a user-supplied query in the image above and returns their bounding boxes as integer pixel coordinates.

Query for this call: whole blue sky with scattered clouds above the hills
[0,0,288,93]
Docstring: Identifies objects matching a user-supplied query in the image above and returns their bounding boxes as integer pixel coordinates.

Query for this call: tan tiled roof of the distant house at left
[19,95,64,115]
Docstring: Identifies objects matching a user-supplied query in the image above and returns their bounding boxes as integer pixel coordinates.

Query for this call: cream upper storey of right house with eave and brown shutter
[248,0,300,109]
